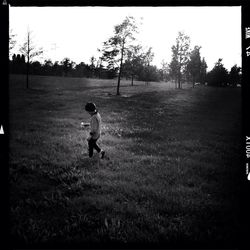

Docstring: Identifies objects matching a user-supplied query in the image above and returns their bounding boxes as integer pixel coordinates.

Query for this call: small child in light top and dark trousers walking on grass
[81,102,105,159]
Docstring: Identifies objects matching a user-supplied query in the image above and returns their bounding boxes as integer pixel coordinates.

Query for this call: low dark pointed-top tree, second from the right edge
[207,58,229,86]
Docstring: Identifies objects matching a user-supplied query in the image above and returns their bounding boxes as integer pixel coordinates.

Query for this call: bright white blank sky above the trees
[9,6,241,70]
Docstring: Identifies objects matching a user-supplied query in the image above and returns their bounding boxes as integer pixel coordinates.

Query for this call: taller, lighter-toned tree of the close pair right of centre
[170,32,190,88]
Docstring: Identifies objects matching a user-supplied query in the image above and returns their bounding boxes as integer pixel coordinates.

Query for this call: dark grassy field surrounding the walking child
[9,75,241,248]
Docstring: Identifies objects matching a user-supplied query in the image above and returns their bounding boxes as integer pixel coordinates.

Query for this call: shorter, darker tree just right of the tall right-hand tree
[187,46,201,88]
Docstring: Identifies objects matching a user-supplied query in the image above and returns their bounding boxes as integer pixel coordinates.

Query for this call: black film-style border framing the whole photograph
[0,0,250,249]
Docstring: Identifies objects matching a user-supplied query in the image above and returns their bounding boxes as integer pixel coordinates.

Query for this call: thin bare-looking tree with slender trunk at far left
[20,29,43,88]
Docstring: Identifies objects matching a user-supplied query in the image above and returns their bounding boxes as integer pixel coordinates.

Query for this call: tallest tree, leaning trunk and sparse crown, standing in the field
[100,17,137,95]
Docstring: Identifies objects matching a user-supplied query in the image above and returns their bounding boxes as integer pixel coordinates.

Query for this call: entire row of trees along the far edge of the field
[10,17,241,95]
